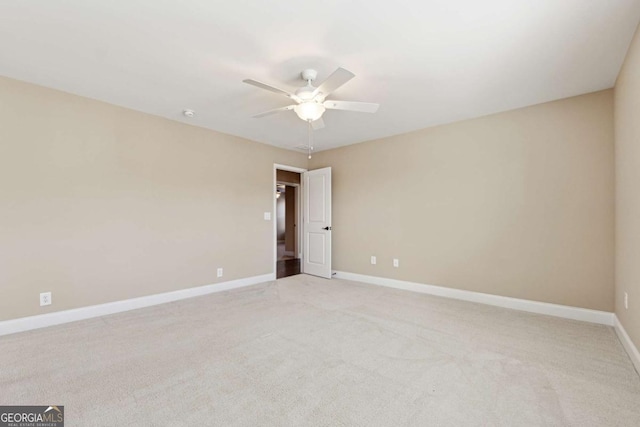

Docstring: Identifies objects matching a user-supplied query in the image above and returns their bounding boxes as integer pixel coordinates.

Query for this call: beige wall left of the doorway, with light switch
[0,78,307,320]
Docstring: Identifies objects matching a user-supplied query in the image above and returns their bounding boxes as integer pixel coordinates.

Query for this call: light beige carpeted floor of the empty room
[0,275,640,427]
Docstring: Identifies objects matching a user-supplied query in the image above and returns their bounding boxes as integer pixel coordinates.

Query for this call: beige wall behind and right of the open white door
[310,90,616,311]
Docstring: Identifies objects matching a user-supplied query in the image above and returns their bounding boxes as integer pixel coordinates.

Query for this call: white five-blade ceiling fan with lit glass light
[243,68,379,129]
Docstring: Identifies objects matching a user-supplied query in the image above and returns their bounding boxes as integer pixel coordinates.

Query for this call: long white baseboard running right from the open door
[334,271,615,326]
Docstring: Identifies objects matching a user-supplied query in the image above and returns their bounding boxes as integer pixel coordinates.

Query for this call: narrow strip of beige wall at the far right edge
[615,21,640,348]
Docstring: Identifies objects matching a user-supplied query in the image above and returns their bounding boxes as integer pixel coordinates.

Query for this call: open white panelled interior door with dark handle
[302,168,331,279]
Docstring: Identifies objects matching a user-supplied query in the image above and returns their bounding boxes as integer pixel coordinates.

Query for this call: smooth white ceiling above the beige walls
[0,0,640,149]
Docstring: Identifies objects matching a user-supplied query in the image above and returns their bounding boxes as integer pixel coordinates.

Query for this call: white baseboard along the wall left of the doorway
[0,273,276,336]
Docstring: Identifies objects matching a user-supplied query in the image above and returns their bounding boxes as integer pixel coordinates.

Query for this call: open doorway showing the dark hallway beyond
[275,168,302,279]
